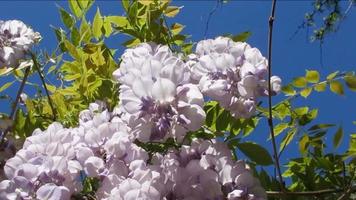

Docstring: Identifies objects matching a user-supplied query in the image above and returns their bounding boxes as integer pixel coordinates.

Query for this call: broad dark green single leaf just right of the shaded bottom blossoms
[237,142,273,165]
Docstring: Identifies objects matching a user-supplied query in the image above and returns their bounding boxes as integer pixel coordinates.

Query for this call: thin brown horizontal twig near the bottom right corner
[267,186,356,197]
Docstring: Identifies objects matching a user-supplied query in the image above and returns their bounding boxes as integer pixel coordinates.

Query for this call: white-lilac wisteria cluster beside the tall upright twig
[187,37,281,118]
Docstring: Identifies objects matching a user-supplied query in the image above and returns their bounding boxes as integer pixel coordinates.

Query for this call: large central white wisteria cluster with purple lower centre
[113,43,205,142]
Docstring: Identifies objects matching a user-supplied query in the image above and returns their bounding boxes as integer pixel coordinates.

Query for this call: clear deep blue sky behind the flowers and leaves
[0,1,356,171]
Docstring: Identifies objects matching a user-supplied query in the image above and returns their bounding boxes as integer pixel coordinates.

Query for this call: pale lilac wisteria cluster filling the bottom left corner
[0,122,82,200]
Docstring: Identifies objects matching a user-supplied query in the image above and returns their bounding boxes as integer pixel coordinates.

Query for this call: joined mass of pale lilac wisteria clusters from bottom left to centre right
[0,37,281,200]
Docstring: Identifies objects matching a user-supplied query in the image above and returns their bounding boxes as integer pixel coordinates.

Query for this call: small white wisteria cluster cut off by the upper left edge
[0,20,41,69]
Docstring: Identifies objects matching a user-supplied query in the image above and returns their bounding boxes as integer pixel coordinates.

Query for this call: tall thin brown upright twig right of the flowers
[268,0,284,191]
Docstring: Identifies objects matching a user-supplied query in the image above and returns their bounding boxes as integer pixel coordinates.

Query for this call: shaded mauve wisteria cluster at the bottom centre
[153,139,267,200]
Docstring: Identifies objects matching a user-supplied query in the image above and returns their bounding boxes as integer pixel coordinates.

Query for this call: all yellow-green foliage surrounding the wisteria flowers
[0,0,356,199]
